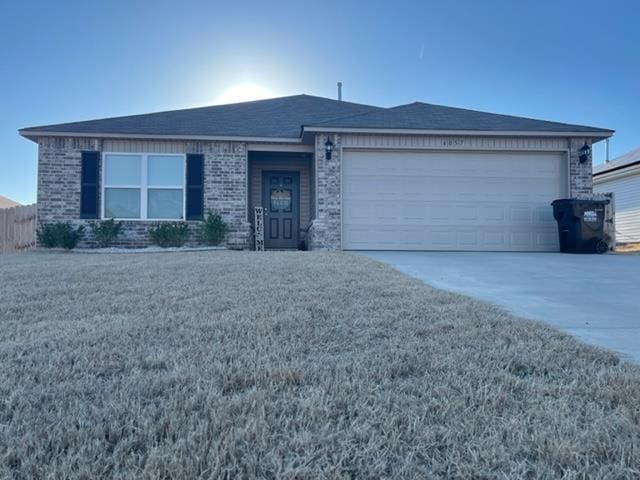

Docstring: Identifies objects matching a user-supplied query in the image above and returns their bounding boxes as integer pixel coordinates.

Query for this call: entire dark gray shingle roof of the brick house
[20,95,613,138]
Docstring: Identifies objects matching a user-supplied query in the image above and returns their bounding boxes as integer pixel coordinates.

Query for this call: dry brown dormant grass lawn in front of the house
[0,252,640,479]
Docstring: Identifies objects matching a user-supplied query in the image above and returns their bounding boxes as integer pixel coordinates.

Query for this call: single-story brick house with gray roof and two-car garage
[20,95,613,251]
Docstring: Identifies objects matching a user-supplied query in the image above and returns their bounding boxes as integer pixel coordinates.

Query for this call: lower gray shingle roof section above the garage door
[308,102,613,134]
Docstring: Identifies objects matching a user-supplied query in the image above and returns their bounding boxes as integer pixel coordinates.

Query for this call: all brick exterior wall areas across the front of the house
[38,134,592,250]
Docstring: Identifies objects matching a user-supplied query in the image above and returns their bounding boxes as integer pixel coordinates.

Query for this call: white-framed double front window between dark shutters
[102,153,185,220]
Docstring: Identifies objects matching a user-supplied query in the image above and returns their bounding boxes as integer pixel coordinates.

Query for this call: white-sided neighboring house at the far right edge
[593,148,640,243]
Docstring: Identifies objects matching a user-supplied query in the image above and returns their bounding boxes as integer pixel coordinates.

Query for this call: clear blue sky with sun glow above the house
[0,0,640,203]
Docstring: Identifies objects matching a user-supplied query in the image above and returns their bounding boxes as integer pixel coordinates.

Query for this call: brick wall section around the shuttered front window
[38,137,250,248]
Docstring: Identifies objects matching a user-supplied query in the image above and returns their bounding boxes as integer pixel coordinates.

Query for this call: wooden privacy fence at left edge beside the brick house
[0,204,36,253]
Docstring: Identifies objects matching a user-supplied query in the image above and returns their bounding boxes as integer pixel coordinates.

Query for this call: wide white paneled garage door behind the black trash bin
[342,150,568,251]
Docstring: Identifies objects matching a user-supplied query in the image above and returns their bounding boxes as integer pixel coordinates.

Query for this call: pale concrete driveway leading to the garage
[364,252,640,363]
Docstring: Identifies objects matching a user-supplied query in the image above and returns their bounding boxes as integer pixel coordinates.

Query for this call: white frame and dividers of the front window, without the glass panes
[100,152,187,222]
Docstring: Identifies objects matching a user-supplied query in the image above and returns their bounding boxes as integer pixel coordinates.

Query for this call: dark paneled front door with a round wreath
[262,172,300,248]
